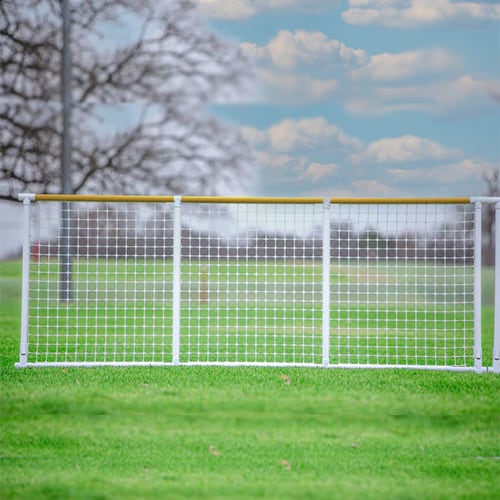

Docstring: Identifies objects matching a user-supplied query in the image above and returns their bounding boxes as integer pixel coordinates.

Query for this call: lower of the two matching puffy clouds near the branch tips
[242,117,361,153]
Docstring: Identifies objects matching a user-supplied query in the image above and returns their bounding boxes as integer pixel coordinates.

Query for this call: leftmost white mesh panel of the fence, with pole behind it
[19,197,173,365]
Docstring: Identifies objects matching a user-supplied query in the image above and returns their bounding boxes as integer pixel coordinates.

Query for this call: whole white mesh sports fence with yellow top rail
[16,194,500,373]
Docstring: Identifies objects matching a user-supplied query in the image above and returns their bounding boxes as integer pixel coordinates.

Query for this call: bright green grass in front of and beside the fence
[0,262,500,499]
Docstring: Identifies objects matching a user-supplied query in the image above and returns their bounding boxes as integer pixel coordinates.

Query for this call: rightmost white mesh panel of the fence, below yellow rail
[330,203,475,368]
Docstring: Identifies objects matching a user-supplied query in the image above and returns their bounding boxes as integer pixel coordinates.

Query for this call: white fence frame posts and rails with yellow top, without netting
[16,193,500,373]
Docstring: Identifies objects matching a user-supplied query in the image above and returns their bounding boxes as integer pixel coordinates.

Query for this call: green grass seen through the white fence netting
[20,258,484,367]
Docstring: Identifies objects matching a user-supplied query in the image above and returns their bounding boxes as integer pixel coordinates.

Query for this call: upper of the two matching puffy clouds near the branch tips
[241,30,366,70]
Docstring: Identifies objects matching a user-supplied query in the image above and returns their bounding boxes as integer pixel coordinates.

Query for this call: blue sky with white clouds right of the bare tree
[199,0,500,196]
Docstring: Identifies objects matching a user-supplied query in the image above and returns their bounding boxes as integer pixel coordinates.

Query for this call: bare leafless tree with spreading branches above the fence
[0,0,251,200]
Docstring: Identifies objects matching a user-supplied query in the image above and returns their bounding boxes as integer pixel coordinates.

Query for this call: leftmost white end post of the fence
[16,193,35,368]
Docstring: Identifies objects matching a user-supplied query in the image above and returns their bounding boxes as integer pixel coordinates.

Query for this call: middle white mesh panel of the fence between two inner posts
[180,203,322,365]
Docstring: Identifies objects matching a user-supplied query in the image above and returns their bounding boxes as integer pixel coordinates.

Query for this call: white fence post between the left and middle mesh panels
[172,196,182,365]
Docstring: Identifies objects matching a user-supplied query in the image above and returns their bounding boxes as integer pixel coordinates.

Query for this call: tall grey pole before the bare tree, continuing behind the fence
[60,0,73,302]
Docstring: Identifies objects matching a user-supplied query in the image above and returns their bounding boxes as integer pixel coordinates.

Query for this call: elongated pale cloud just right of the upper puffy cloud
[351,49,461,81]
